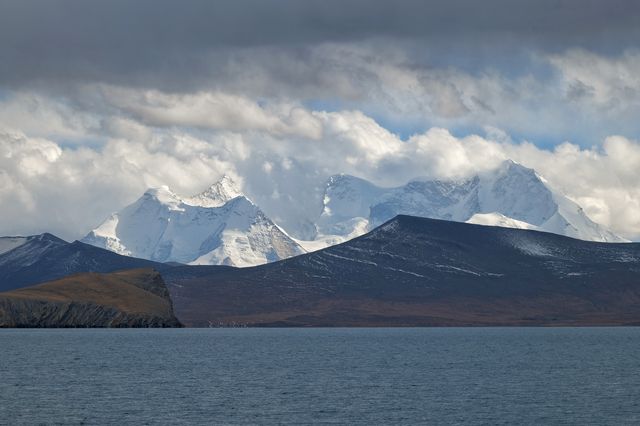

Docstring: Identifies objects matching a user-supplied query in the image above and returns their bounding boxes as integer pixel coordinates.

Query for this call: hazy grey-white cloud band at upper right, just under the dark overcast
[206,44,640,146]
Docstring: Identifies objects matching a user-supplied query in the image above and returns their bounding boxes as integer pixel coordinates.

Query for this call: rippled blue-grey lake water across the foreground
[0,328,640,425]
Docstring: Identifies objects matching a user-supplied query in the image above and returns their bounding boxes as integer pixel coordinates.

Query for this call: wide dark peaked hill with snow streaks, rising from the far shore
[165,216,640,326]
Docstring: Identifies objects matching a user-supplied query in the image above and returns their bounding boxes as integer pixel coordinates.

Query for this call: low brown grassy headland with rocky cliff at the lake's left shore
[0,269,181,327]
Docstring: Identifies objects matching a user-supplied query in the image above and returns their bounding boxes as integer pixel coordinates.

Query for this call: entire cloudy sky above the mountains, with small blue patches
[0,0,640,240]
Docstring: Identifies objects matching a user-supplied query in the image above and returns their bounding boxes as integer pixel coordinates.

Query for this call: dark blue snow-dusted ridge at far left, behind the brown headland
[0,234,169,291]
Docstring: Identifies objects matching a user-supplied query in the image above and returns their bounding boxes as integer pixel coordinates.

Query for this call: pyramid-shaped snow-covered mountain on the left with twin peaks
[81,176,304,267]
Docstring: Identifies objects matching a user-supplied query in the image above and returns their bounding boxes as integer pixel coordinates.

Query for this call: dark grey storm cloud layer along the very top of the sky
[0,0,640,87]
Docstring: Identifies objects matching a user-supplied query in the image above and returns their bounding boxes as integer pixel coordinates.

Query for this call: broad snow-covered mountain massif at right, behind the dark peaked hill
[310,160,625,245]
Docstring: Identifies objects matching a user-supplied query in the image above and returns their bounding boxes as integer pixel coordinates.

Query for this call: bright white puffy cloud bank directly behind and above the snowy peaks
[0,100,640,243]
